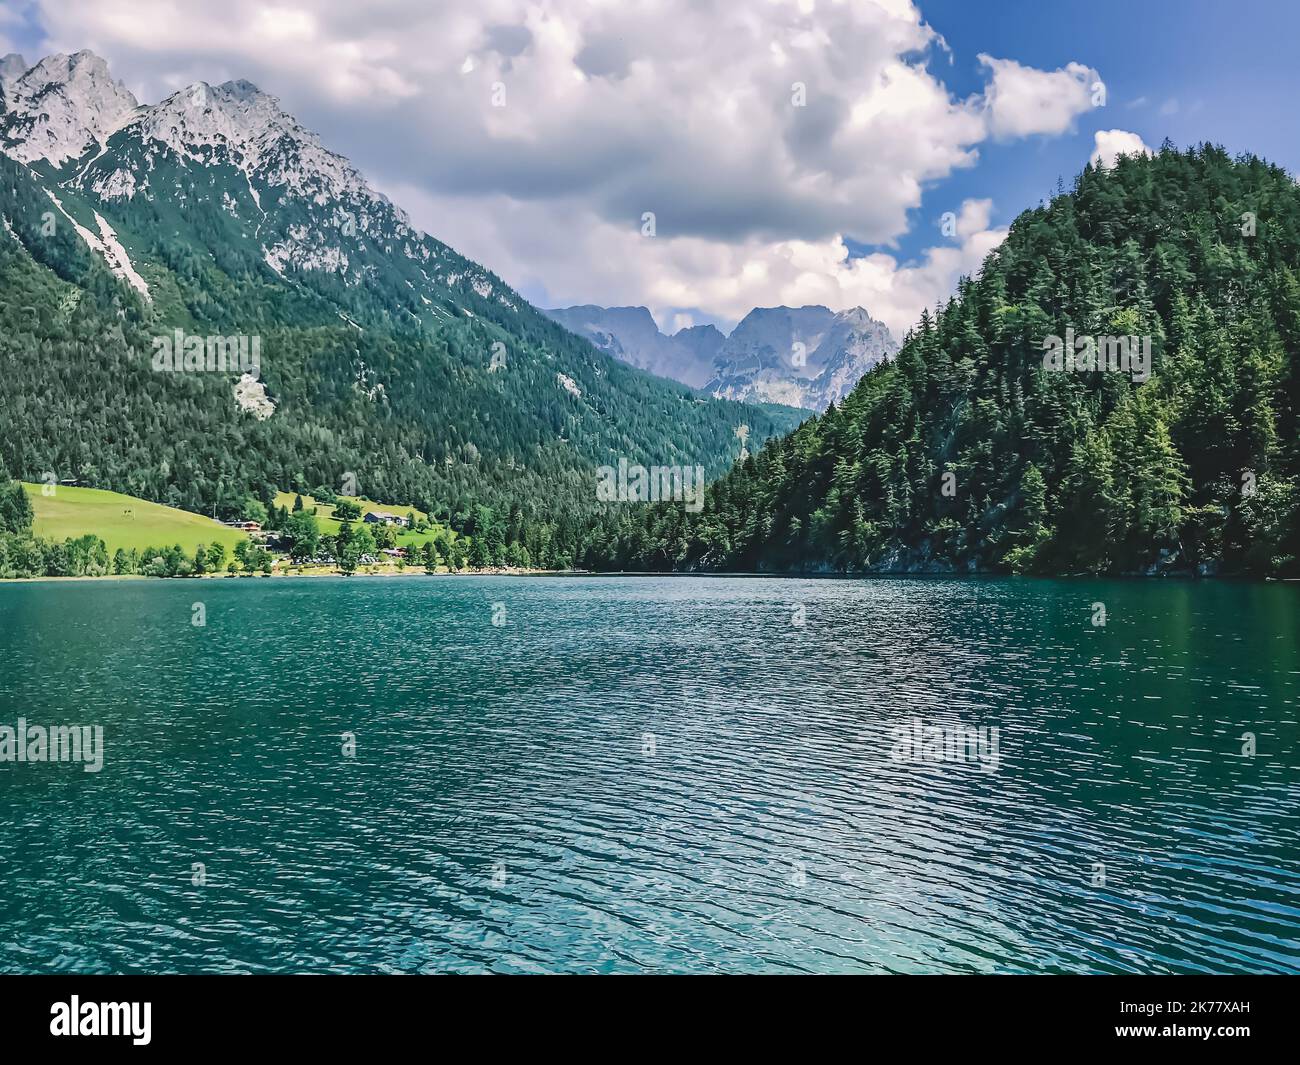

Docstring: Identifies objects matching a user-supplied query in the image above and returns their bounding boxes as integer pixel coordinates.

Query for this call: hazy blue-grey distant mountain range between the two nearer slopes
[546,306,898,411]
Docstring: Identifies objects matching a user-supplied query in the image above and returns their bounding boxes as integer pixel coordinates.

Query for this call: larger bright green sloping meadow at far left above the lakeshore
[23,484,247,554]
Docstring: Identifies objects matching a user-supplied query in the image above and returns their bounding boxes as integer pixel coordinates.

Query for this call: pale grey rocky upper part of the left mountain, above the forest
[0,52,519,324]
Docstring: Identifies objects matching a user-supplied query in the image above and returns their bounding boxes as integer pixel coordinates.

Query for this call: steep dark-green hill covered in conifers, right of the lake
[586,144,1300,579]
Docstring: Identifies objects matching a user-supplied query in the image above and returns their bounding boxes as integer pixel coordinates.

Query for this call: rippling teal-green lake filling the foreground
[0,575,1300,973]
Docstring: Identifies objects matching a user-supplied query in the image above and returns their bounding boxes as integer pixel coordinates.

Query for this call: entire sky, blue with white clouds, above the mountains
[0,0,1300,335]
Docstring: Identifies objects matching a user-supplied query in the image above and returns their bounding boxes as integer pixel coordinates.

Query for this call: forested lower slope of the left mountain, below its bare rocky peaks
[0,150,801,553]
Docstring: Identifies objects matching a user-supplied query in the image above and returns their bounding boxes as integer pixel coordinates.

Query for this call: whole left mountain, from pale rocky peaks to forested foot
[0,52,797,561]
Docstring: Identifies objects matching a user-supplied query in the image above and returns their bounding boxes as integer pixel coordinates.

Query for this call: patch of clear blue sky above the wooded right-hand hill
[873,0,1300,263]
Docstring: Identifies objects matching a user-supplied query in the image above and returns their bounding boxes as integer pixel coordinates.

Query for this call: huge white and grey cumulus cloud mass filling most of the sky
[27,0,1099,325]
